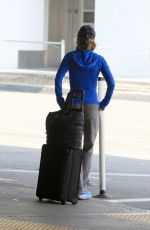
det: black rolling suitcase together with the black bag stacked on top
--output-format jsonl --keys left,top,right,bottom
{"left": 36, "top": 90, "right": 84, "bottom": 204}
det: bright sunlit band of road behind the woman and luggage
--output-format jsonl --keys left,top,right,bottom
{"left": 0, "top": 88, "right": 150, "bottom": 159}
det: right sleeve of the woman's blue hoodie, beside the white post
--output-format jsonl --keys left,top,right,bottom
{"left": 99, "top": 58, "right": 115, "bottom": 109}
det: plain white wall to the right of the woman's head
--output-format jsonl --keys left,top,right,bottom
{"left": 95, "top": 0, "right": 150, "bottom": 79}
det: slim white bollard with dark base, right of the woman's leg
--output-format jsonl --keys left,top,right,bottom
{"left": 95, "top": 77, "right": 110, "bottom": 198}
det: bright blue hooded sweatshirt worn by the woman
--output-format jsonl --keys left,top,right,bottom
{"left": 55, "top": 50, "right": 115, "bottom": 109}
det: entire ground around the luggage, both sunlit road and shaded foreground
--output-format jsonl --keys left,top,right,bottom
{"left": 0, "top": 74, "right": 150, "bottom": 230}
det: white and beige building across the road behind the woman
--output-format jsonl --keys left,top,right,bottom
{"left": 0, "top": 0, "right": 150, "bottom": 79}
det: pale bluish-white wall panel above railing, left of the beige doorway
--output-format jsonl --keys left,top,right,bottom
{"left": 17, "top": 0, "right": 44, "bottom": 41}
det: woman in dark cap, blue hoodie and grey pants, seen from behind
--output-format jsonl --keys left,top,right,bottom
{"left": 55, "top": 25, "right": 115, "bottom": 200}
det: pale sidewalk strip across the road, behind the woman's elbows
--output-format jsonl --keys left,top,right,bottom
{"left": 0, "top": 73, "right": 150, "bottom": 101}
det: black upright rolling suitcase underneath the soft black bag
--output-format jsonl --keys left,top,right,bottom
{"left": 36, "top": 144, "right": 82, "bottom": 204}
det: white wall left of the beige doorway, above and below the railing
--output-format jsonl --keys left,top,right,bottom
{"left": 0, "top": 0, "right": 44, "bottom": 68}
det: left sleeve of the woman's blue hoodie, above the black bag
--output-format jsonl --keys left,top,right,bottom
{"left": 55, "top": 54, "right": 69, "bottom": 109}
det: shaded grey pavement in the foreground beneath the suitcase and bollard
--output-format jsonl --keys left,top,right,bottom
{"left": 0, "top": 146, "right": 150, "bottom": 230}
